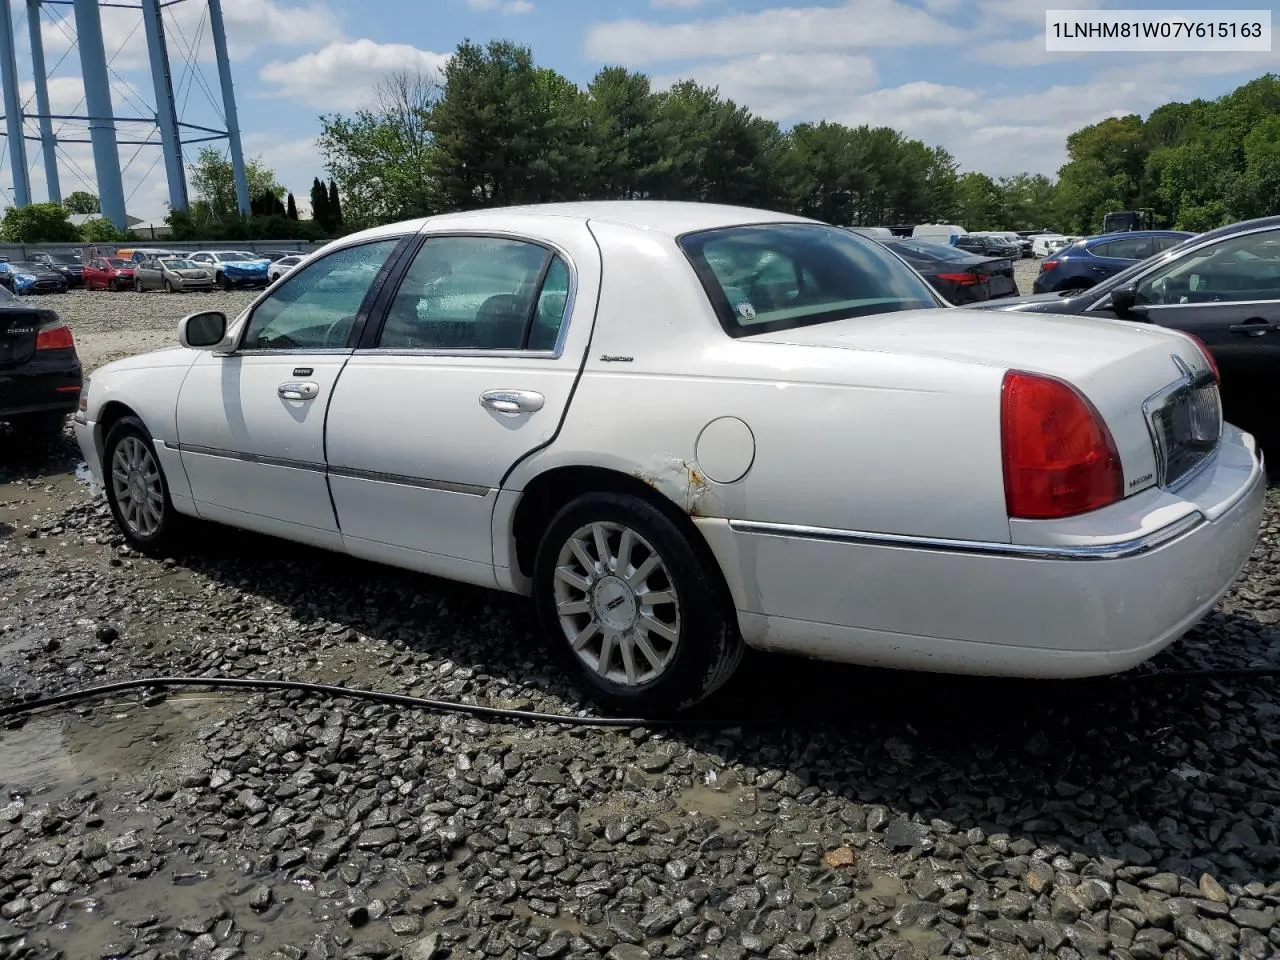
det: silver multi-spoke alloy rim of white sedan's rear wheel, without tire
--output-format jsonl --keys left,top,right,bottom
{"left": 554, "top": 522, "right": 680, "bottom": 687}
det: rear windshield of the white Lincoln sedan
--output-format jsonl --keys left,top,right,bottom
{"left": 680, "top": 223, "right": 942, "bottom": 337}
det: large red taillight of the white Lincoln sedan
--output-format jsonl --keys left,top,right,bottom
{"left": 1000, "top": 370, "right": 1124, "bottom": 520}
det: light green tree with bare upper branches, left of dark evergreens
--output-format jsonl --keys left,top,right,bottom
{"left": 320, "top": 72, "right": 440, "bottom": 228}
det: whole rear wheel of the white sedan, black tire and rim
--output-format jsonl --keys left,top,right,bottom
{"left": 534, "top": 493, "right": 742, "bottom": 717}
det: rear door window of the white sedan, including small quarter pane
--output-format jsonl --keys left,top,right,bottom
{"left": 378, "top": 237, "right": 568, "bottom": 351}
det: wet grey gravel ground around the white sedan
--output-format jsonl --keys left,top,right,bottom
{"left": 0, "top": 271, "right": 1280, "bottom": 960}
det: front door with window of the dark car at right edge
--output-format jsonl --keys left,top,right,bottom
{"left": 1134, "top": 228, "right": 1280, "bottom": 456}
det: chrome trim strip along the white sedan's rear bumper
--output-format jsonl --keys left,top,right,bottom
{"left": 728, "top": 511, "right": 1208, "bottom": 561}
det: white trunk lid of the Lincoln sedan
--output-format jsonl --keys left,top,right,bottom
{"left": 745, "top": 307, "right": 1217, "bottom": 495}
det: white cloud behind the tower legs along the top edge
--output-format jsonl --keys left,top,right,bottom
{"left": 36, "top": 0, "right": 342, "bottom": 72}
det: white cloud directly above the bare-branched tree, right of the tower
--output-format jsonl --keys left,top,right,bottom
{"left": 260, "top": 38, "right": 449, "bottom": 111}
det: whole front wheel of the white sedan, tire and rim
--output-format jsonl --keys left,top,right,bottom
{"left": 102, "top": 416, "right": 183, "bottom": 556}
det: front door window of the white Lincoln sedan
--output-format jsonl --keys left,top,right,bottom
{"left": 241, "top": 237, "right": 401, "bottom": 349}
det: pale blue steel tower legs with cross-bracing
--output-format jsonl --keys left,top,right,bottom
{"left": 0, "top": 0, "right": 250, "bottom": 230}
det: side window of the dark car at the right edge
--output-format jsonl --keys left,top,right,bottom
{"left": 1134, "top": 230, "right": 1280, "bottom": 306}
